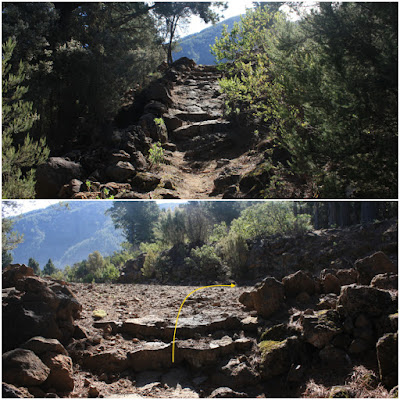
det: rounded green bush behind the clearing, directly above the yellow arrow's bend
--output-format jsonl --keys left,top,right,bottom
{"left": 185, "top": 244, "right": 224, "bottom": 280}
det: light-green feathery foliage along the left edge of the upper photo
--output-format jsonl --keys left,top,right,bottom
{"left": 2, "top": 39, "right": 49, "bottom": 199}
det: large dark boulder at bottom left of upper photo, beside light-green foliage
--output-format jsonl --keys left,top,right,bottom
{"left": 35, "top": 157, "right": 82, "bottom": 199}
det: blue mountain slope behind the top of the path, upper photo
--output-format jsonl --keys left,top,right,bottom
{"left": 173, "top": 15, "right": 240, "bottom": 65}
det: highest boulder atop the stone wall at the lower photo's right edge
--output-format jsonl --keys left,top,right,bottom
{"left": 355, "top": 251, "right": 397, "bottom": 285}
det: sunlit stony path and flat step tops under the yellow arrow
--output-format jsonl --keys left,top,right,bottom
{"left": 67, "top": 283, "right": 255, "bottom": 398}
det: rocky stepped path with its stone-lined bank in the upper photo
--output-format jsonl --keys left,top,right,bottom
{"left": 36, "top": 58, "right": 265, "bottom": 199}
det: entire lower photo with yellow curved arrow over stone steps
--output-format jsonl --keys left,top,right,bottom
{"left": 2, "top": 200, "right": 398, "bottom": 398}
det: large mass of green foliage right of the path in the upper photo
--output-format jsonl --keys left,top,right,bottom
{"left": 213, "top": 2, "right": 397, "bottom": 198}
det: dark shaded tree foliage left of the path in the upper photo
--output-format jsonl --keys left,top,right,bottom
{"left": 2, "top": 2, "right": 163, "bottom": 149}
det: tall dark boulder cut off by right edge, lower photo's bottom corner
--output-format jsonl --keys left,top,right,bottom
{"left": 376, "top": 332, "right": 398, "bottom": 389}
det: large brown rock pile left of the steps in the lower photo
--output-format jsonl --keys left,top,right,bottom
{"left": 2, "top": 264, "right": 82, "bottom": 397}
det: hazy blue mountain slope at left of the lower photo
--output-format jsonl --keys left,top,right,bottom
{"left": 13, "top": 201, "right": 124, "bottom": 268}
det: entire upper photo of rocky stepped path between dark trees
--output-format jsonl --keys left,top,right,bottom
{"left": 2, "top": 1, "right": 398, "bottom": 199}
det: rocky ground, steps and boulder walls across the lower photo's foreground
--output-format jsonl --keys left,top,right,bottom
{"left": 3, "top": 221, "right": 398, "bottom": 398}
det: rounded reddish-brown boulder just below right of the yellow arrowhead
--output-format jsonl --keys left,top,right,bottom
{"left": 251, "top": 277, "right": 285, "bottom": 318}
